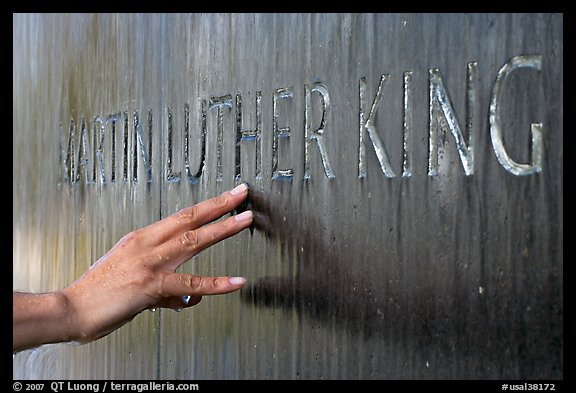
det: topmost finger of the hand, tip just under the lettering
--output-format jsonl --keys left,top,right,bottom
{"left": 146, "top": 183, "right": 248, "bottom": 243}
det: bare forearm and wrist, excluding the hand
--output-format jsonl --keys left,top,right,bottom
{"left": 12, "top": 292, "right": 76, "bottom": 352}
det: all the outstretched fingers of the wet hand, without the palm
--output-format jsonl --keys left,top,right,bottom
{"left": 138, "top": 184, "right": 253, "bottom": 309}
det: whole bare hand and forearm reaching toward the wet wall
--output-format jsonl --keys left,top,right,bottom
{"left": 12, "top": 184, "right": 253, "bottom": 352}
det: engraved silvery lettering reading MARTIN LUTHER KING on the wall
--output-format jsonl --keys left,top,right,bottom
{"left": 58, "top": 55, "right": 543, "bottom": 186}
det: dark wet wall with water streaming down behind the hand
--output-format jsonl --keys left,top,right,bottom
{"left": 13, "top": 14, "right": 563, "bottom": 380}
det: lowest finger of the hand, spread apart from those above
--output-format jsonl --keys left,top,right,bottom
{"left": 161, "top": 273, "right": 246, "bottom": 298}
